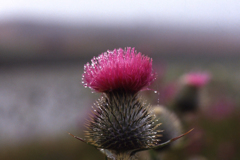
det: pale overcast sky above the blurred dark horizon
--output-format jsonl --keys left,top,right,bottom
{"left": 0, "top": 0, "right": 240, "bottom": 28}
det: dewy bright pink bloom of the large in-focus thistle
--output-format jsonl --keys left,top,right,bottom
{"left": 82, "top": 47, "right": 155, "bottom": 93}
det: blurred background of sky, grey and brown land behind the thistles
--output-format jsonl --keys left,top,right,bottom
{"left": 0, "top": 0, "right": 240, "bottom": 160}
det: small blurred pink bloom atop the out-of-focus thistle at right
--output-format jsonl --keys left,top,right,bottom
{"left": 181, "top": 72, "right": 211, "bottom": 88}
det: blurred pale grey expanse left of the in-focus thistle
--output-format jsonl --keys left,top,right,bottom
{"left": 0, "top": 64, "right": 91, "bottom": 146}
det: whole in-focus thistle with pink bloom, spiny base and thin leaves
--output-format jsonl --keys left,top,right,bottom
{"left": 72, "top": 48, "right": 192, "bottom": 159}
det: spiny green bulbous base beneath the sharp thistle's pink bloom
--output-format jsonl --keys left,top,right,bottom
{"left": 86, "top": 92, "right": 161, "bottom": 153}
